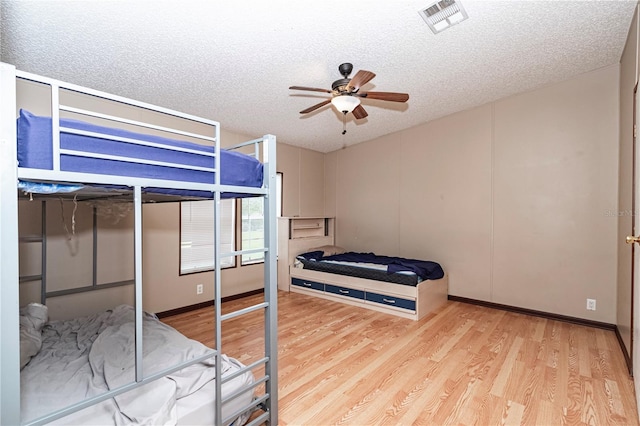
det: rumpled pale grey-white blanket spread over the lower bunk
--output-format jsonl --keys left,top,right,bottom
{"left": 21, "top": 305, "right": 235, "bottom": 425}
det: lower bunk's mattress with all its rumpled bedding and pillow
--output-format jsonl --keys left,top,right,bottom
{"left": 20, "top": 304, "right": 254, "bottom": 425}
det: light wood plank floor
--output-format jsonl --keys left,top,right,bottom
{"left": 164, "top": 292, "right": 638, "bottom": 425}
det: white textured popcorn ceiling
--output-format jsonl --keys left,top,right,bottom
{"left": 0, "top": 0, "right": 636, "bottom": 152}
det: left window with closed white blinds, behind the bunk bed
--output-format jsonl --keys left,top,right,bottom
{"left": 180, "top": 199, "right": 235, "bottom": 275}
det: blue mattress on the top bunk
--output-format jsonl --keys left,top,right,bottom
{"left": 18, "top": 110, "right": 263, "bottom": 195}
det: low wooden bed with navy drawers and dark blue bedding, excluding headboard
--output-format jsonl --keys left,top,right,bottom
{"left": 290, "top": 246, "right": 448, "bottom": 320}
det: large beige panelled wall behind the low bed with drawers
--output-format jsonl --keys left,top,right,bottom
{"left": 325, "top": 66, "right": 619, "bottom": 324}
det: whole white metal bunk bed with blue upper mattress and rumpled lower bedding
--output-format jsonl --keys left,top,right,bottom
{"left": 0, "top": 63, "right": 277, "bottom": 425}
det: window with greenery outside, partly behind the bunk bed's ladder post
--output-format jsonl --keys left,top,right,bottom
{"left": 241, "top": 173, "right": 282, "bottom": 265}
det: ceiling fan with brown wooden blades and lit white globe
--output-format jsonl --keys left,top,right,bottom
{"left": 289, "top": 62, "right": 409, "bottom": 135}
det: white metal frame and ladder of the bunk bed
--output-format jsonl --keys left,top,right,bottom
{"left": 0, "top": 63, "right": 278, "bottom": 425}
